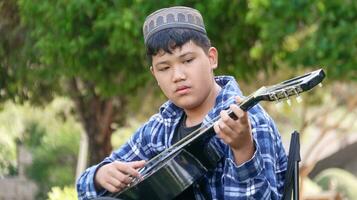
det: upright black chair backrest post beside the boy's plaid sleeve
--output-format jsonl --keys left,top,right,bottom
{"left": 282, "top": 131, "right": 301, "bottom": 200}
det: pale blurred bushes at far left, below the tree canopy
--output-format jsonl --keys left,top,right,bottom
{"left": 0, "top": 98, "right": 81, "bottom": 198}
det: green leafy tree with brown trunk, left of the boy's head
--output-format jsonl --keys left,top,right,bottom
{"left": 14, "top": 0, "right": 154, "bottom": 164}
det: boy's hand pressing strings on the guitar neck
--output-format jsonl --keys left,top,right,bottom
{"left": 214, "top": 97, "right": 255, "bottom": 165}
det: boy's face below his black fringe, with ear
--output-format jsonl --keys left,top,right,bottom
{"left": 150, "top": 41, "right": 217, "bottom": 109}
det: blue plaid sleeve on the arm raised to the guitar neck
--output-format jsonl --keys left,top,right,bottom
{"left": 209, "top": 105, "right": 287, "bottom": 199}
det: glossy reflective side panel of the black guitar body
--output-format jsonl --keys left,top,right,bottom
{"left": 114, "top": 149, "right": 203, "bottom": 200}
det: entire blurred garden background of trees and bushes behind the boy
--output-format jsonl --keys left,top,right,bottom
{"left": 0, "top": 0, "right": 357, "bottom": 200}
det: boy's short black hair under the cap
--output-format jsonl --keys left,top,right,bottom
{"left": 145, "top": 28, "right": 211, "bottom": 63}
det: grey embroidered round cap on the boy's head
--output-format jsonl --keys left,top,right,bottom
{"left": 143, "top": 6, "right": 206, "bottom": 44}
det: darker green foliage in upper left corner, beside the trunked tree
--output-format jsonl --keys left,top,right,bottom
{"left": 0, "top": 0, "right": 55, "bottom": 104}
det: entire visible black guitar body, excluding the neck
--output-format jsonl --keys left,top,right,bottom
{"left": 107, "top": 129, "right": 221, "bottom": 200}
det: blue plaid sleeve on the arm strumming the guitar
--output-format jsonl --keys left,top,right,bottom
{"left": 76, "top": 118, "right": 156, "bottom": 200}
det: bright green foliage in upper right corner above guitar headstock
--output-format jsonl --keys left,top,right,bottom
{"left": 246, "top": 0, "right": 357, "bottom": 80}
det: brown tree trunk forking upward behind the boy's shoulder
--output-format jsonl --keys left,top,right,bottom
{"left": 71, "top": 79, "right": 125, "bottom": 166}
